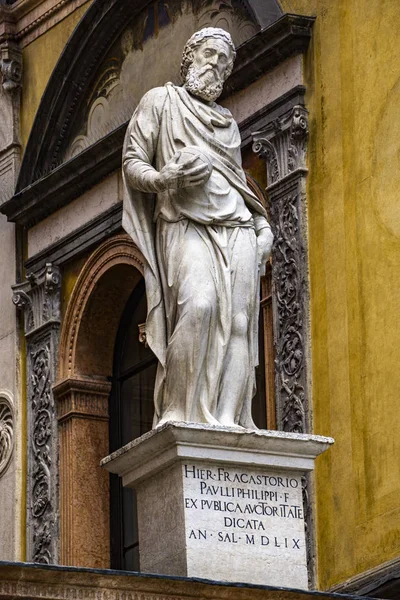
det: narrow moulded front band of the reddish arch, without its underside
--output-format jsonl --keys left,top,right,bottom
{"left": 59, "top": 234, "right": 144, "bottom": 381}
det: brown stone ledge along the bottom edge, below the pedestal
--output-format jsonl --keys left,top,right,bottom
{"left": 0, "top": 562, "right": 370, "bottom": 600}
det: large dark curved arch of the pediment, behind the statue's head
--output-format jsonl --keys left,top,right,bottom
{"left": 16, "top": 0, "right": 283, "bottom": 194}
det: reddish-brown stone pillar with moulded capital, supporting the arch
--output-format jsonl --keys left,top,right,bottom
{"left": 54, "top": 377, "right": 111, "bottom": 569}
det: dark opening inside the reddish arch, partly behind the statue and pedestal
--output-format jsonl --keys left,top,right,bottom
{"left": 109, "top": 279, "right": 157, "bottom": 571}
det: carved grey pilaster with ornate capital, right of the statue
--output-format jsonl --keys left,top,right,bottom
{"left": 253, "top": 105, "right": 310, "bottom": 433}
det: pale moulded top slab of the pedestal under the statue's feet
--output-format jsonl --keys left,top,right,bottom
{"left": 101, "top": 421, "right": 334, "bottom": 486}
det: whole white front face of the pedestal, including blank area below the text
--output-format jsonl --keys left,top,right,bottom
{"left": 182, "top": 462, "right": 307, "bottom": 587}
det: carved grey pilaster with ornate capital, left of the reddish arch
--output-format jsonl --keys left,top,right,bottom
{"left": 13, "top": 264, "right": 61, "bottom": 564}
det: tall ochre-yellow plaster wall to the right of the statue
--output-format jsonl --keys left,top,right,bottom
{"left": 282, "top": 0, "right": 400, "bottom": 589}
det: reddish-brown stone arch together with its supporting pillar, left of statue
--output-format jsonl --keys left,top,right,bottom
{"left": 53, "top": 234, "right": 144, "bottom": 568}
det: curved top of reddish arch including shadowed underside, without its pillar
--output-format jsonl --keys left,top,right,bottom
{"left": 59, "top": 235, "right": 144, "bottom": 380}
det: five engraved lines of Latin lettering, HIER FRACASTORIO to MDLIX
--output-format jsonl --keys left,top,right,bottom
{"left": 183, "top": 463, "right": 305, "bottom": 559}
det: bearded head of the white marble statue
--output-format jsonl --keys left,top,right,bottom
{"left": 181, "top": 27, "right": 236, "bottom": 101}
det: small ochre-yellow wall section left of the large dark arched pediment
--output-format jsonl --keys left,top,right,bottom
{"left": 21, "top": 2, "right": 89, "bottom": 149}
